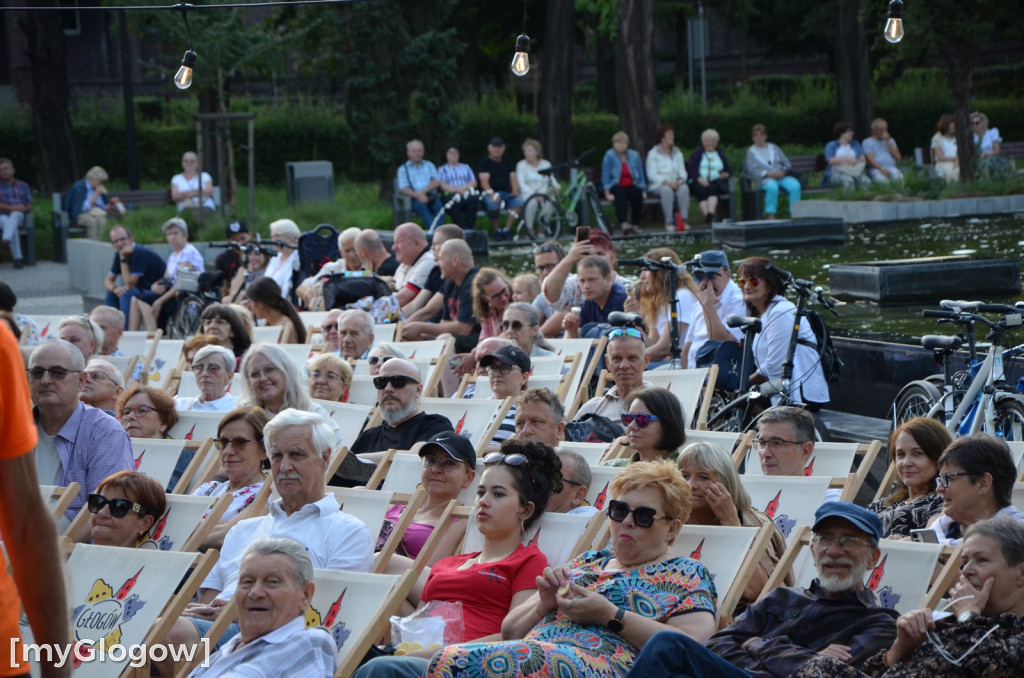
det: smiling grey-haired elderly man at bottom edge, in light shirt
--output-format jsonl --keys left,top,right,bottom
{"left": 188, "top": 537, "right": 338, "bottom": 678}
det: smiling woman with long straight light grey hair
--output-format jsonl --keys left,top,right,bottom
{"left": 241, "top": 344, "right": 341, "bottom": 446}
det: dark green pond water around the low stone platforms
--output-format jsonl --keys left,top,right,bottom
{"left": 488, "top": 214, "right": 1024, "bottom": 344}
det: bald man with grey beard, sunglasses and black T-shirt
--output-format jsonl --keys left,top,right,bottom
{"left": 331, "top": 357, "right": 455, "bottom": 486}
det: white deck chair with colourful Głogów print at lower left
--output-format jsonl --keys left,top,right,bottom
{"left": 59, "top": 544, "right": 218, "bottom": 678}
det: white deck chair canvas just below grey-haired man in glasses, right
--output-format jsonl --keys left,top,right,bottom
{"left": 742, "top": 475, "right": 830, "bottom": 544}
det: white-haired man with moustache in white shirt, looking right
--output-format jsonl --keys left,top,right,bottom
{"left": 155, "top": 408, "right": 374, "bottom": 676}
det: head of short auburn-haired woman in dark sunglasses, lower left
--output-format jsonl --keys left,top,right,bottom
{"left": 86, "top": 471, "right": 167, "bottom": 549}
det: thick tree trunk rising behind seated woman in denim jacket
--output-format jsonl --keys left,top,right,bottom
{"left": 615, "top": 0, "right": 659, "bottom": 151}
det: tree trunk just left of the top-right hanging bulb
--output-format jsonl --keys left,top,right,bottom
{"left": 834, "top": 0, "right": 874, "bottom": 137}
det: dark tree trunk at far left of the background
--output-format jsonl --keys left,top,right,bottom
{"left": 19, "top": 5, "right": 78, "bottom": 192}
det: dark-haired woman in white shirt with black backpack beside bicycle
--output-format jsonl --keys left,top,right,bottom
{"left": 736, "top": 257, "right": 828, "bottom": 412}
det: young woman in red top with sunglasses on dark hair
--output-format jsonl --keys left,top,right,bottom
{"left": 353, "top": 439, "right": 562, "bottom": 678}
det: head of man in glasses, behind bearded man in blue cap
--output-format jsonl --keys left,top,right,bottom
{"left": 751, "top": 405, "right": 843, "bottom": 502}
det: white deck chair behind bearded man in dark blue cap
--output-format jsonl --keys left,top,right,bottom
{"left": 761, "top": 526, "right": 963, "bottom": 615}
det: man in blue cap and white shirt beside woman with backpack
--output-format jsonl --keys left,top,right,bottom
{"left": 680, "top": 250, "right": 746, "bottom": 370}
